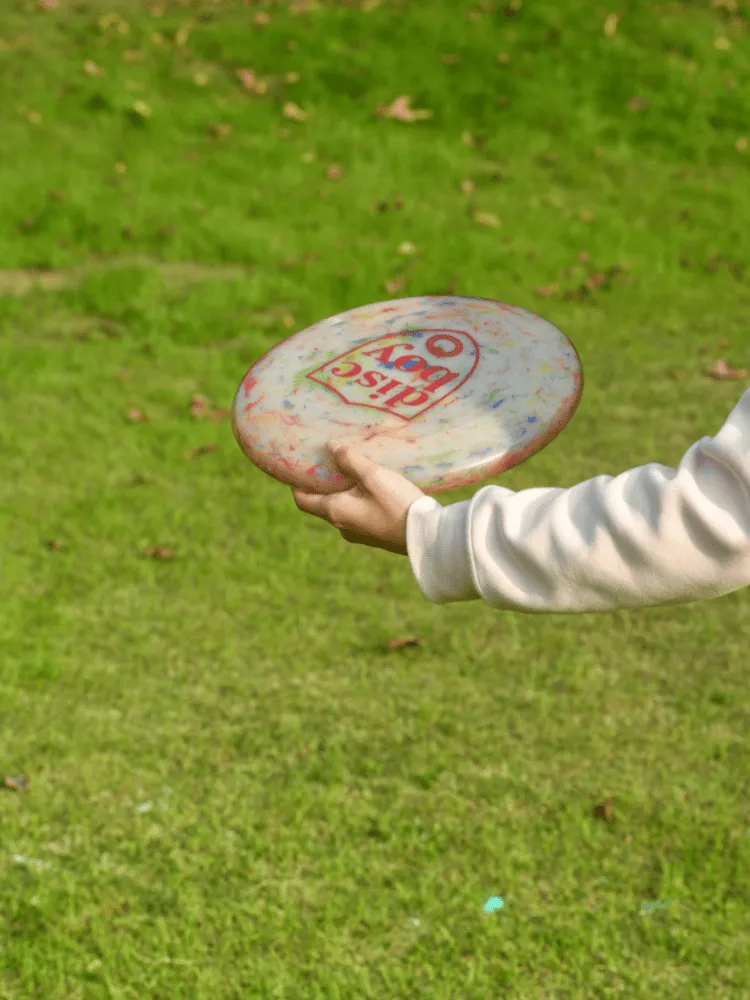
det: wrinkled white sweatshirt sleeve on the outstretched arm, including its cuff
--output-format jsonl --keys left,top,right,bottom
{"left": 407, "top": 390, "right": 750, "bottom": 614}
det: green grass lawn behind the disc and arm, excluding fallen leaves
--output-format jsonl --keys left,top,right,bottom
{"left": 0, "top": 0, "right": 750, "bottom": 1000}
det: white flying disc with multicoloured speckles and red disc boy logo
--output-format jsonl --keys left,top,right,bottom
{"left": 232, "top": 295, "right": 583, "bottom": 494}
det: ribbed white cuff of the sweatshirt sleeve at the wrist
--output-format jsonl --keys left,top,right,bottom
{"left": 406, "top": 496, "right": 481, "bottom": 604}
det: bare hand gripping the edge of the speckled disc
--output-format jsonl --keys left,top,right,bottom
{"left": 292, "top": 441, "right": 424, "bottom": 556}
